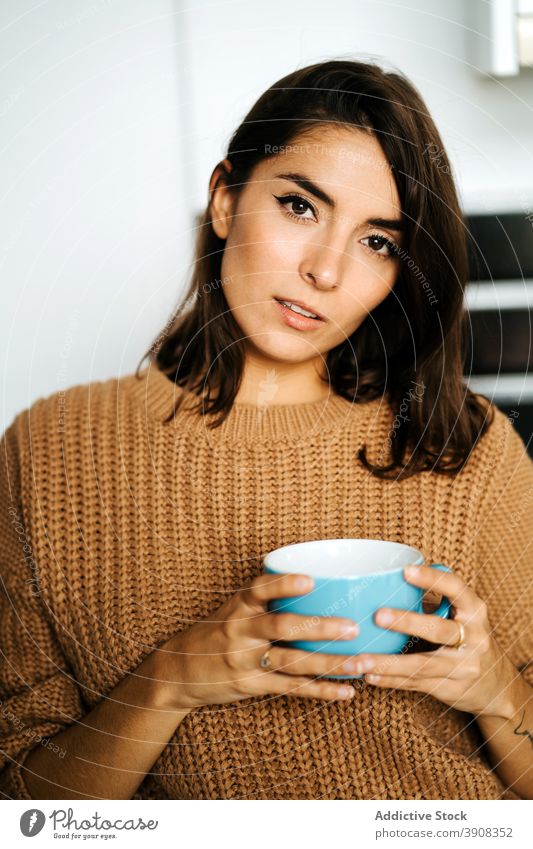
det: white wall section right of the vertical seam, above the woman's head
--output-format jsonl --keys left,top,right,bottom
{"left": 182, "top": 0, "right": 533, "bottom": 211}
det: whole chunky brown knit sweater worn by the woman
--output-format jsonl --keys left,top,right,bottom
{"left": 0, "top": 367, "right": 533, "bottom": 799}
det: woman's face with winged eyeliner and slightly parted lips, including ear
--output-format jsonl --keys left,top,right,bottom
{"left": 211, "top": 127, "right": 401, "bottom": 373}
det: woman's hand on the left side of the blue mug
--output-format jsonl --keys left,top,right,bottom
{"left": 156, "top": 574, "right": 359, "bottom": 710}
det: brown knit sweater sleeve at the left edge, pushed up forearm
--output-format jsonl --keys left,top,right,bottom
{"left": 0, "top": 411, "right": 83, "bottom": 799}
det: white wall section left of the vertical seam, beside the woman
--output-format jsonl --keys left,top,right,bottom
{"left": 0, "top": 0, "right": 191, "bottom": 426}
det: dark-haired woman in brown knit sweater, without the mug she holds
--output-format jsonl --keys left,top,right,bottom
{"left": 0, "top": 61, "right": 533, "bottom": 799}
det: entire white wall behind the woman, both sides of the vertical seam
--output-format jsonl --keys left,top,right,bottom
{"left": 0, "top": 0, "right": 533, "bottom": 426}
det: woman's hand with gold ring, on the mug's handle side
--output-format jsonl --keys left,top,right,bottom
{"left": 350, "top": 566, "right": 518, "bottom": 716}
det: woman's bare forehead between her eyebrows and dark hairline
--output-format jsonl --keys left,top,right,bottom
{"left": 254, "top": 125, "right": 400, "bottom": 213}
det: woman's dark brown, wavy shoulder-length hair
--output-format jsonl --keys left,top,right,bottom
{"left": 136, "top": 60, "right": 493, "bottom": 479}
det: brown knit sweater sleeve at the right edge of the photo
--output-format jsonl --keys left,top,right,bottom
{"left": 475, "top": 408, "right": 533, "bottom": 685}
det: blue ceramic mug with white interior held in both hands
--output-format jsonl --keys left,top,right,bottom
{"left": 263, "top": 539, "right": 452, "bottom": 678}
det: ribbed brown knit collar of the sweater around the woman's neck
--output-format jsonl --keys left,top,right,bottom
{"left": 129, "top": 365, "right": 376, "bottom": 441}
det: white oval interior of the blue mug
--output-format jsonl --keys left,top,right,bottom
{"left": 263, "top": 538, "right": 424, "bottom": 578}
